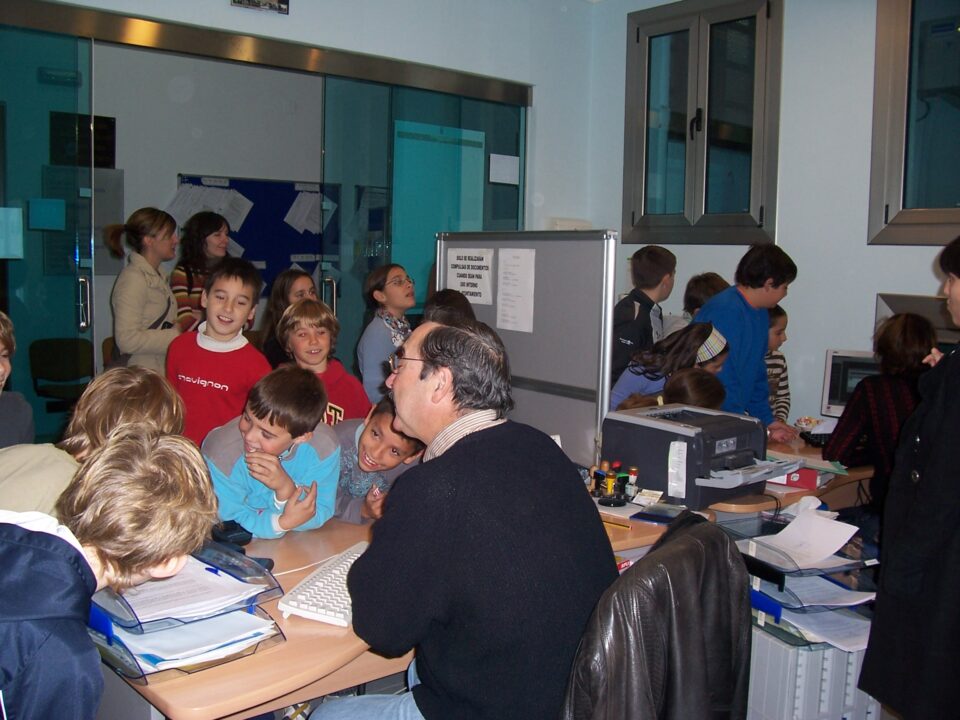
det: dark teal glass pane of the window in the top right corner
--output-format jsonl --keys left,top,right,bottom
{"left": 903, "top": 0, "right": 960, "bottom": 209}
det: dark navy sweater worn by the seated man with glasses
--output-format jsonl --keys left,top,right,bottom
{"left": 348, "top": 422, "right": 617, "bottom": 720}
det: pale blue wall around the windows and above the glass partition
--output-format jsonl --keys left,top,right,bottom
{"left": 62, "top": 0, "right": 952, "bottom": 416}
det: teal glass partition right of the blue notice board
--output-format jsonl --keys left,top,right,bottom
{"left": 323, "top": 77, "right": 525, "bottom": 367}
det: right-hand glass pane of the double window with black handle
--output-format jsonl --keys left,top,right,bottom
{"left": 705, "top": 17, "right": 756, "bottom": 214}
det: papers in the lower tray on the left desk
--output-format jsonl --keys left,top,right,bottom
{"left": 115, "top": 610, "right": 278, "bottom": 672}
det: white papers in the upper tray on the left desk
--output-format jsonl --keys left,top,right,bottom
{"left": 123, "top": 556, "right": 263, "bottom": 623}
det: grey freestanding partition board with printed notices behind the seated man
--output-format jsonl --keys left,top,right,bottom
{"left": 437, "top": 230, "right": 617, "bottom": 466}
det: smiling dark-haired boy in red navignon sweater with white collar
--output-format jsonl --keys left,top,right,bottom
{"left": 167, "top": 257, "right": 270, "bottom": 446}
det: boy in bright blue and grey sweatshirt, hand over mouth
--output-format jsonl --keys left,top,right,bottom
{"left": 203, "top": 365, "right": 340, "bottom": 538}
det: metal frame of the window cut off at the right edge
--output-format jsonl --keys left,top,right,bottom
{"left": 867, "top": 0, "right": 960, "bottom": 245}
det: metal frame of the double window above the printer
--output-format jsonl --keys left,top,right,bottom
{"left": 621, "top": 0, "right": 783, "bottom": 245}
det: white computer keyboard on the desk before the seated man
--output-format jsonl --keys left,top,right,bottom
{"left": 278, "top": 541, "right": 370, "bottom": 627}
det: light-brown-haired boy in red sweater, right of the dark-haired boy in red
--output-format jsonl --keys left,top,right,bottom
{"left": 277, "top": 298, "right": 370, "bottom": 425}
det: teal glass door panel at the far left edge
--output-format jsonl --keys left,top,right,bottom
{"left": 0, "top": 26, "right": 93, "bottom": 442}
